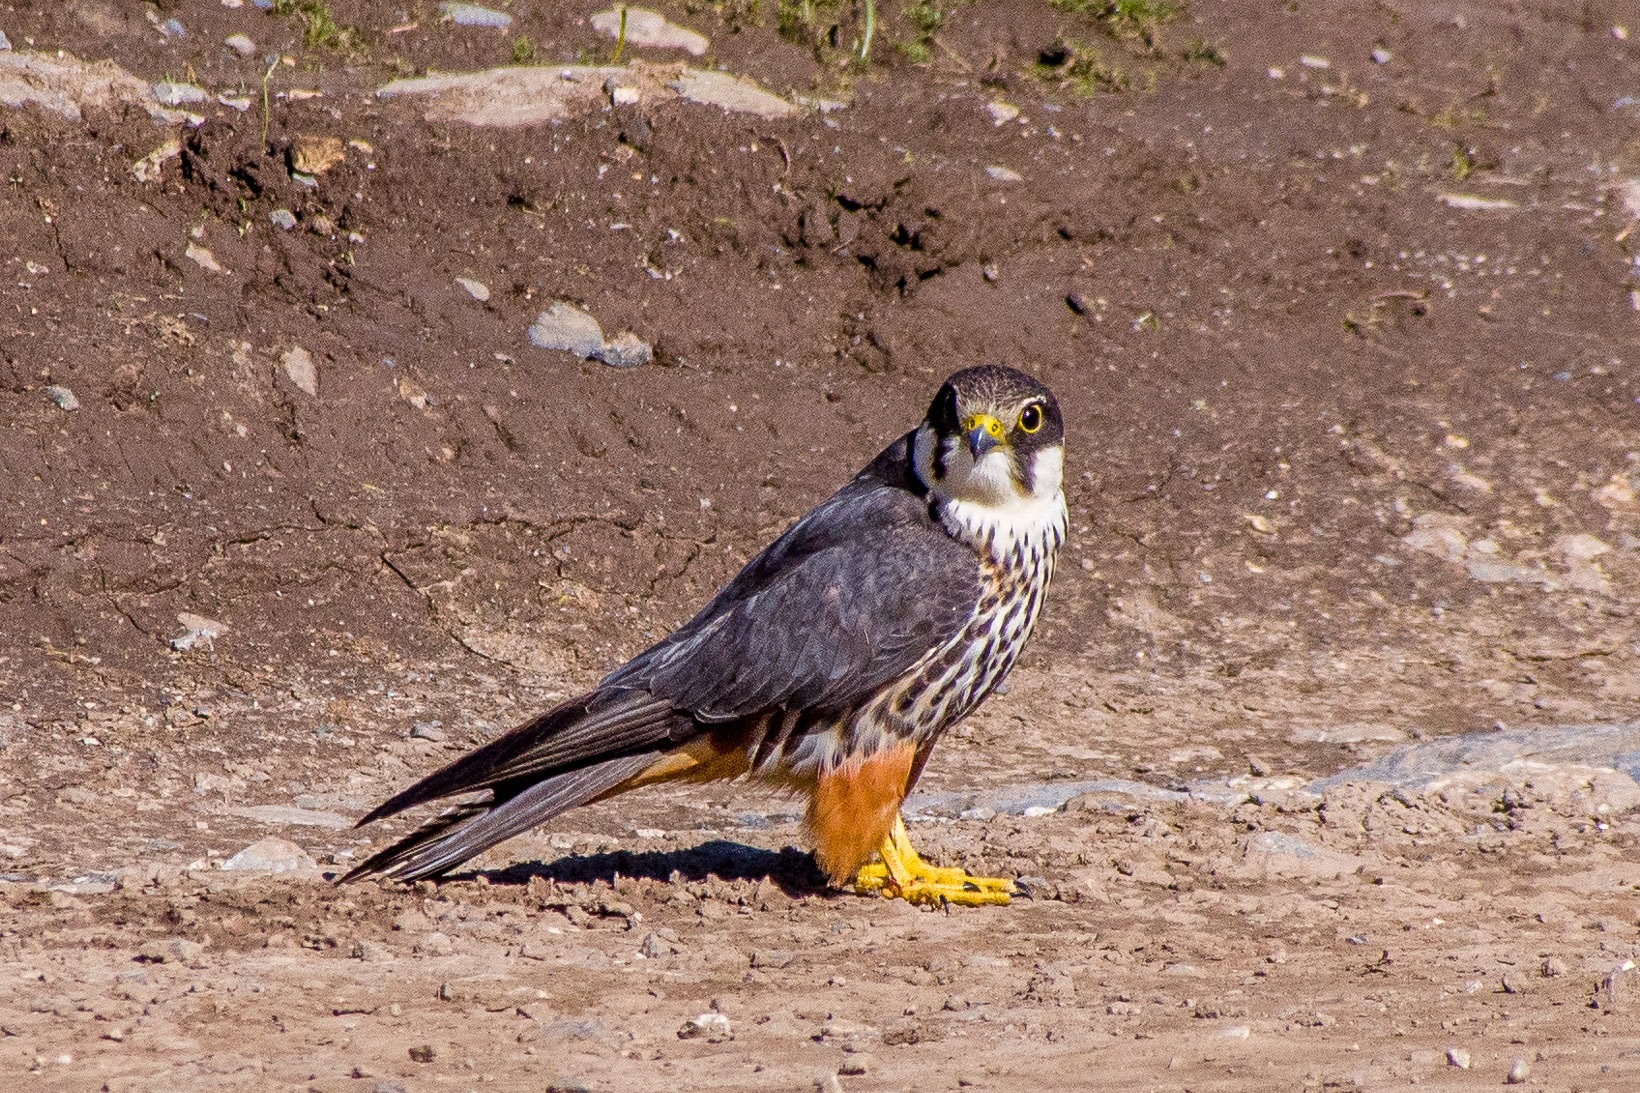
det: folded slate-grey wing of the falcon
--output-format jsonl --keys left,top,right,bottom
{"left": 602, "top": 479, "right": 982, "bottom": 722}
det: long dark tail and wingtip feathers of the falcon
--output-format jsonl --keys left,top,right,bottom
{"left": 341, "top": 691, "right": 700, "bottom": 883}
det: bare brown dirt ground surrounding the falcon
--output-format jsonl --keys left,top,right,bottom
{"left": 0, "top": 0, "right": 1640, "bottom": 1093}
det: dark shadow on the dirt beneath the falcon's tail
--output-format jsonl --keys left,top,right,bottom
{"left": 451, "top": 839, "right": 830, "bottom": 899}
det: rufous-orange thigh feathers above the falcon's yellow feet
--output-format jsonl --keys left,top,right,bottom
{"left": 804, "top": 742, "right": 917, "bottom": 886}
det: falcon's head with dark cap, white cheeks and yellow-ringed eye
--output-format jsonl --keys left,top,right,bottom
{"left": 912, "top": 364, "right": 1064, "bottom": 509}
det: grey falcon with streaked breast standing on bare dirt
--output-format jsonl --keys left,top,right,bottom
{"left": 343, "top": 366, "right": 1066, "bottom": 904}
